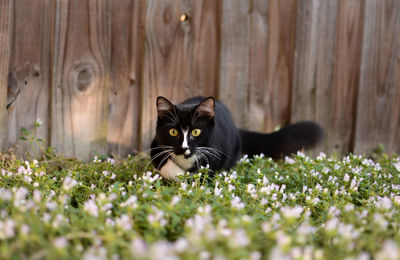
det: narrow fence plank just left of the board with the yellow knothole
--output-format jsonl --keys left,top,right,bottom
{"left": 107, "top": 0, "right": 145, "bottom": 156}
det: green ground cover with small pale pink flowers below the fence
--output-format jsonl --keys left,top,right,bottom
{"left": 0, "top": 153, "right": 400, "bottom": 259}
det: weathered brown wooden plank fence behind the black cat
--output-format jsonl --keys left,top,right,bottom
{"left": 0, "top": 0, "right": 400, "bottom": 159}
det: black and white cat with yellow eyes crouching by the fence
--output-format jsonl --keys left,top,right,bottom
{"left": 151, "top": 97, "right": 323, "bottom": 180}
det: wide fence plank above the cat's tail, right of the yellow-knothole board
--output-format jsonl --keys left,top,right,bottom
{"left": 219, "top": 0, "right": 297, "bottom": 132}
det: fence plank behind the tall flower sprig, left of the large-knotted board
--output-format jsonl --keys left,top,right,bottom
{"left": 5, "top": 0, "right": 53, "bottom": 155}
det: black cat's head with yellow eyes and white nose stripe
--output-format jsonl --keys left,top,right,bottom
{"left": 156, "top": 97, "right": 215, "bottom": 158}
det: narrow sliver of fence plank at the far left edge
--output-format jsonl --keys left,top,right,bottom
{"left": 0, "top": 0, "right": 11, "bottom": 151}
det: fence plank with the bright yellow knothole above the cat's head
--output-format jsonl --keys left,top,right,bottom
{"left": 141, "top": 0, "right": 219, "bottom": 149}
